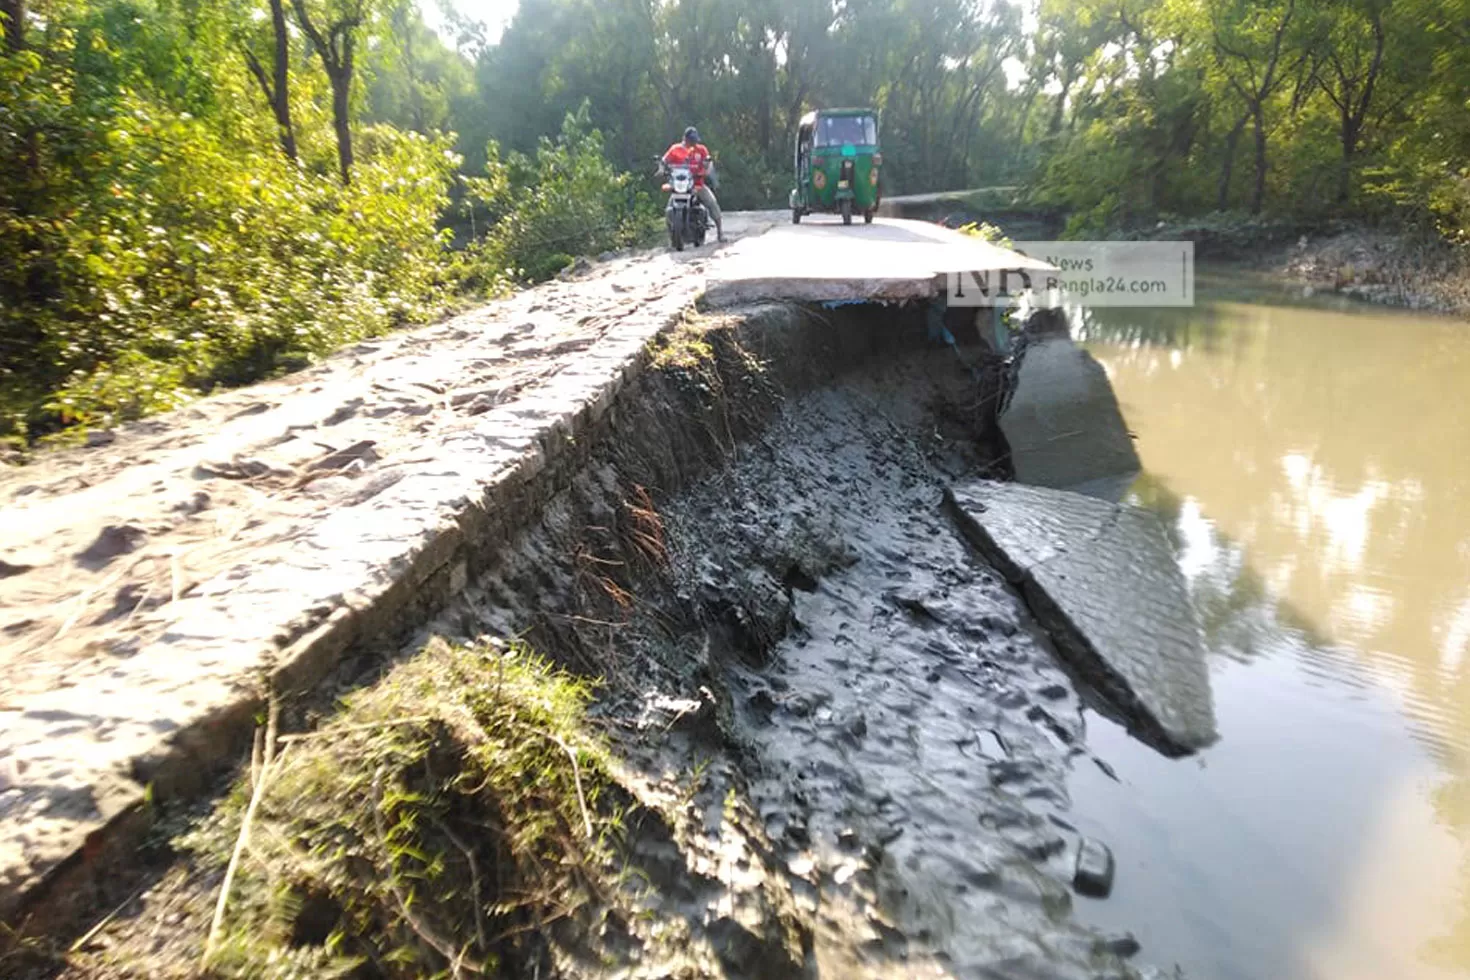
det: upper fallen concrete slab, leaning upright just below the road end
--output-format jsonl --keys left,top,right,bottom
{"left": 1000, "top": 335, "right": 1141, "bottom": 501}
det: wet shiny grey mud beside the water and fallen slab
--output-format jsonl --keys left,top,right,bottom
{"left": 664, "top": 351, "right": 1170, "bottom": 977}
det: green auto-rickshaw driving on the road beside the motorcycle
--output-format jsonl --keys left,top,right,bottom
{"left": 791, "top": 109, "right": 883, "bottom": 225}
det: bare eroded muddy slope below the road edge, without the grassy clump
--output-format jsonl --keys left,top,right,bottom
{"left": 31, "top": 309, "right": 1152, "bottom": 980}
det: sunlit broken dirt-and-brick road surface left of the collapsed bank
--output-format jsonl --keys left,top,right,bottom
{"left": 0, "top": 220, "right": 793, "bottom": 914}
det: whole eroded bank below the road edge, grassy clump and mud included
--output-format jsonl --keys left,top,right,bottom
{"left": 12, "top": 307, "right": 1155, "bottom": 979}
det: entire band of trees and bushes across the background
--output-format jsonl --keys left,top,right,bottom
{"left": 0, "top": 0, "right": 1470, "bottom": 438}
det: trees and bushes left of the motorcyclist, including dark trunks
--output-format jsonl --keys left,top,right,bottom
{"left": 0, "top": 0, "right": 656, "bottom": 438}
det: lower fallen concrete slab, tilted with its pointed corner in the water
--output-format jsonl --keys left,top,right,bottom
{"left": 947, "top": 480, "right": 1216, "bottom": 755}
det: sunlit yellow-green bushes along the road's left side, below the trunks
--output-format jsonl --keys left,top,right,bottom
{"left": 0, "top": 17, "right": 459, "bottom": 438}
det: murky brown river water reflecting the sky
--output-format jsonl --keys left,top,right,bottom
{"left": 1070, "top": 276, "right": 1470, "bottom": 980}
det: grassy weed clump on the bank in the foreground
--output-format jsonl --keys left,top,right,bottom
{"left": 182, "top": 641, "right": 620, "bottom": 979}
